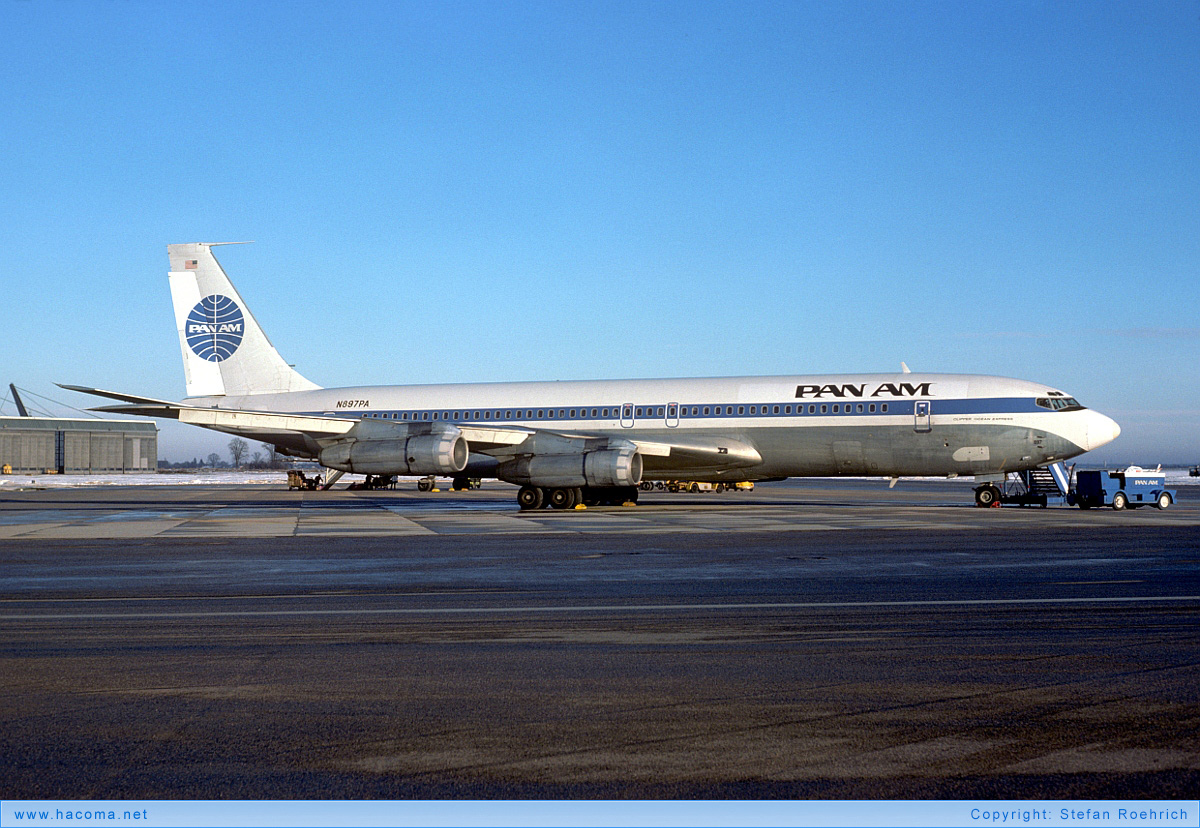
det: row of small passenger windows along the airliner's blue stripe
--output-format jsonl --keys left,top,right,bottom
{"left": 367, "top": 402, "right": 888, "bottom": 422}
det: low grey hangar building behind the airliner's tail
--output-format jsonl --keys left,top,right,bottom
{"left": 0, "top": 416, "right": 158, "bottom": 474}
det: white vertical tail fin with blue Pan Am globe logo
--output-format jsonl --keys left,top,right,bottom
{"left": 167, "top": 244, "right": 320, "bottom": 397}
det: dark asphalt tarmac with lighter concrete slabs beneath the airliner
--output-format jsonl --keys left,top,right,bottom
{"left": 0, "top": 481, "right": 1200, "bottom": 799}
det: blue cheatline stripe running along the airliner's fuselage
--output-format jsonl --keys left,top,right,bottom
{"left": 295, "top": 397, "right": 1052, "bottom": 425}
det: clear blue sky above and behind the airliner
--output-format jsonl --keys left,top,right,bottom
{"left": 0, "top": 0, "right": 1200, "bottom": 463}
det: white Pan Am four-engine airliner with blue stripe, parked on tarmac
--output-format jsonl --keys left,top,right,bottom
{"left": 64, "top": 244, "right": 1121, "bottom": 509}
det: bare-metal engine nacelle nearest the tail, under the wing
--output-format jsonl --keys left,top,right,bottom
{"left": 318, "top": 428, "right": 470, "bottom": 475}
